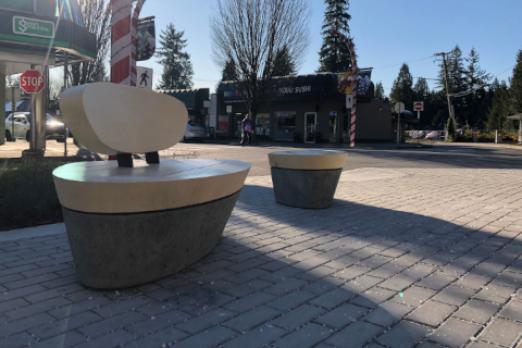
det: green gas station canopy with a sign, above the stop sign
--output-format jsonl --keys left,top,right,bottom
{"left": 0, "top": 0, "right": 97, "bottom": 75}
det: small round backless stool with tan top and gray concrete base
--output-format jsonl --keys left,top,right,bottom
{"left": 268, "top": 150, "right": 347, "bottom": 209}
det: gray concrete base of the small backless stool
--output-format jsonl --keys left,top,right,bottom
{"left": 272, "top": 167, "right": 342, "bottom": 209}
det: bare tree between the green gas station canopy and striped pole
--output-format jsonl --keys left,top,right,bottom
{"left": 70, "top": 0, "right": 111, "bottom": 86}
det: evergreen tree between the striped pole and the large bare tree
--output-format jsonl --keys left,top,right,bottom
{"left": 158, "top": 24, "right": 194, "bottom": 89}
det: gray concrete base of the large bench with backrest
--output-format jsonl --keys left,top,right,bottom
{"left": 63, "top": 193, "right": 239, "bottom": 289}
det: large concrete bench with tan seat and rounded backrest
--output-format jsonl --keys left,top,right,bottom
{"left": 53, "top": 84, "right": 250, "bottom": 289}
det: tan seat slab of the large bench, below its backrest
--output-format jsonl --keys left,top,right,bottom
{"left": 53, "top": 160, "right": 250, "bottom": 213}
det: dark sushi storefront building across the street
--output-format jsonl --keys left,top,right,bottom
{"left": 216, "top": 69, "right": 393, "bottom": 143}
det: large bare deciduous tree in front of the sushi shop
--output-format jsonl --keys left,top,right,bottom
{"left": 212, "top": 0, "right": 309, "bottom": 119}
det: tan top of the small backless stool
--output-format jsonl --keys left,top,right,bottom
{"left": 268, "top": 150, "right": 348, "bottom": 170}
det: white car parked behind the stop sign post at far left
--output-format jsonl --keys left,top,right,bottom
{"left": 5, "top": 112, "right": 65, "bottom": 141}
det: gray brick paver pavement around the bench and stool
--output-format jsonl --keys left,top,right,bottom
{"left": 0, "top": 169, "right": 522, "bottom": 348}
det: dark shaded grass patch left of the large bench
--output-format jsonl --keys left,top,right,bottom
{"left": 0, "top": 158, "right": 73, "bottom": 231}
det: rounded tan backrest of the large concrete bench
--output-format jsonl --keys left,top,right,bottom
{"left": 60, "top": 83, "right": 188, "bottom": 155}
